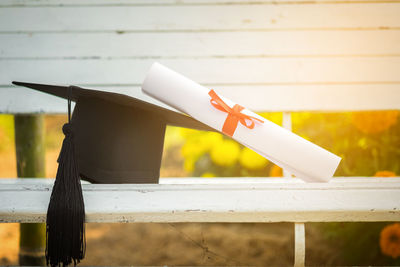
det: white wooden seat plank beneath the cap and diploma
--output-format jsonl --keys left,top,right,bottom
{"left": 0, "top": 177, "right": 400, "bottom": 222}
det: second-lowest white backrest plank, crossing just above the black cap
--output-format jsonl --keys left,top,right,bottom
{"left": 0, "top": 57, "right": 400, "bottom": 86}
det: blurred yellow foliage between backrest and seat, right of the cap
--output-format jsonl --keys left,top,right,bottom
{"left": 181, "top": 111, "right": 400, "bottom": 177}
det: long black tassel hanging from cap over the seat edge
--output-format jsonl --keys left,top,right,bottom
{"left": 46, "top": 90, "right": 86, "bottom": 267}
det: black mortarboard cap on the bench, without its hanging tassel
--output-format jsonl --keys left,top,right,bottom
{"left": 13, "top": 82, "right": 212, "bottom": 184}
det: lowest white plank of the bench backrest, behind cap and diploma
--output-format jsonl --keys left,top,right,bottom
{"left": 0, "top": 84, "right": 400, "bottom": 114}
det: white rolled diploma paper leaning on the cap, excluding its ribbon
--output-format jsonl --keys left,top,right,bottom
{"left": 142, "top": 63, "right": 341, "bottom": 182}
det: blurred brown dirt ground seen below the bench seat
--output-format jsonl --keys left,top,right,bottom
{"left": 0, "top": 223, "right": 336, "bottom": 266}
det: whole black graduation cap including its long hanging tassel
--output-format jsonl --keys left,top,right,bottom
{"left": 13, "top": 82, "right": 212, "bottom": 266}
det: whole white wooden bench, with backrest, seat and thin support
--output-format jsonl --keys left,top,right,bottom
{"left": 0, "top": 0, "right": 400, "bottom": 266}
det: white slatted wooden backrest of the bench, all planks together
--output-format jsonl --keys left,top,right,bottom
{"left": 0, "top": 0, "right": 400, "bottom": 113}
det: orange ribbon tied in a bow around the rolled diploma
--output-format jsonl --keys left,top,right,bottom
{"left": 208, "top": 90, "right": 264, "bottom": 137}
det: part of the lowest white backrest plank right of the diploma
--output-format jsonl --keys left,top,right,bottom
{"left": 215, "top": 84, "right": 400, "bottom": 111}
